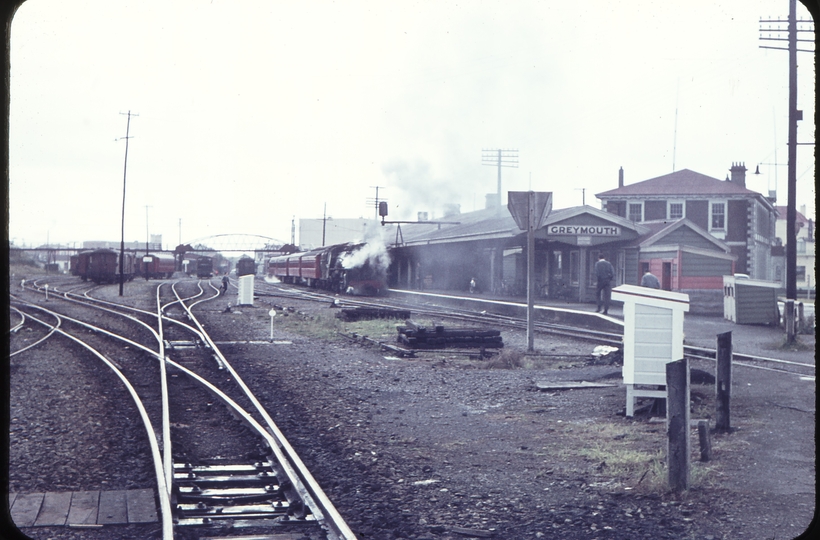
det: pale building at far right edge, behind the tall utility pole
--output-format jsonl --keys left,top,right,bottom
{"left": 772, "top": 205, "right": 817, "bottom": 291}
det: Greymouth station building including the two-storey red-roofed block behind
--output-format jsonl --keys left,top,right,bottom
{"left": 388, "top": 165, "right": 777, "bottom": 315}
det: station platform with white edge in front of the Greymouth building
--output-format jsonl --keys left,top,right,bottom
{"left": 390, "top": 289, "right": 815, "bottom": 363}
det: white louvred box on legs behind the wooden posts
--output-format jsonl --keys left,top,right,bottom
{"left": 612, "top": 285, "right": 689, "bottom": 416}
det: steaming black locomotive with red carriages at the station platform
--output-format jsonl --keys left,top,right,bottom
{"left": 267, "top": 243, "right": 389, "bottom": 296}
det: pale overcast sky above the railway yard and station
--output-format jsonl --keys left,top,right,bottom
{"left": 9, "top": 0, "right": 815, "bottom": 248}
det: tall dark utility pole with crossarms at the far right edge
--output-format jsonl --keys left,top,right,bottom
{"left": 760, "top": 0, "right": 814, "bottom": 343}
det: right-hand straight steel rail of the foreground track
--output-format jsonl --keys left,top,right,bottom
{"left": 178, "top": 281, "right": 356, "bottom": 539}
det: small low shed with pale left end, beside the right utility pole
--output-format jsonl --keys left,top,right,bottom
{"left": 723, "top": 275, "right": 780, "bottom": 325}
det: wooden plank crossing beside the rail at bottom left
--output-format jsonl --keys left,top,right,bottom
{"left": 9, "top": 489, "right": 157, "bottom": 528}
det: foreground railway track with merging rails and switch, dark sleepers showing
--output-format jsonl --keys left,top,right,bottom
{"left": 11, "top": 281, "right": 355, "bottom": 540}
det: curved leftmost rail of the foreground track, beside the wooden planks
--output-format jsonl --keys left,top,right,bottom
{"left": 10, "top": 302, "right": 174, "bottom": 540}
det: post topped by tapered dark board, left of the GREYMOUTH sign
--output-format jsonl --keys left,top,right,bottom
{"left": 507, "top": 191, "right": 552, "bottom": 352}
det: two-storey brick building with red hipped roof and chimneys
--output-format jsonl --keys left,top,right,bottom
{"left": 596, "top": 163, "right": 777, "bottom": 281}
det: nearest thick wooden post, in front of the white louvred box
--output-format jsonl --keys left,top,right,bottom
{"left": 666, "top": 358, "right": 690, "bottom": 492}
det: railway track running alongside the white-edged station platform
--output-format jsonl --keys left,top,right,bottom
{"left": 250, "top": 283, "right": 815, "bottom": 377}
